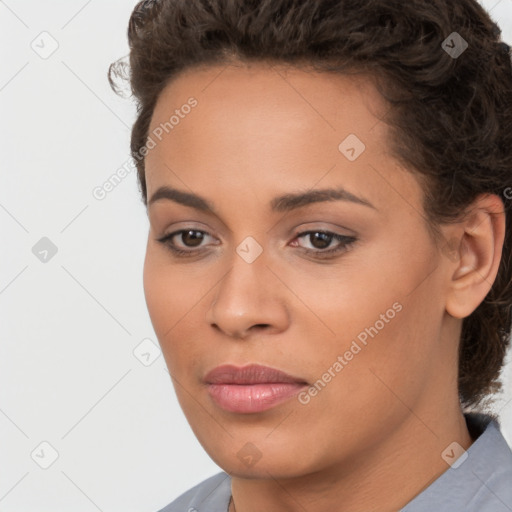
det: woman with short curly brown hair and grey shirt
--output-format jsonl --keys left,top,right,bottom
{"left": 109, "top": 0, "right": 512, "bottom": 512}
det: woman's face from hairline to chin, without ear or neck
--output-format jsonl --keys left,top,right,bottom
{"left": 144, "top": 64, "right": 457, "bottom": 478}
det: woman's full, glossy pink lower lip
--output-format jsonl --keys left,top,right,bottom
{"left": 208, "top": 382, "right": 307, "bottom": 413}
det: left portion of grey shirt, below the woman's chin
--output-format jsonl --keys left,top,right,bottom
{"left": 154, "top": 471, "right": 231, "bottom": 512}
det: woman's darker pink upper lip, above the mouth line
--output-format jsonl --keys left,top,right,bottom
{"left": 204, "top": 364, "right": 307, "bottom": 384}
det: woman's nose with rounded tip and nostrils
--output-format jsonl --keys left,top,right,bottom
{"left": 206, "top": 255, "right": 289, "bottom": 339}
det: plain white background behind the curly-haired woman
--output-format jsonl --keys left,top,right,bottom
{"left": 0, "top": 0, "right": 512, "bottom": 512}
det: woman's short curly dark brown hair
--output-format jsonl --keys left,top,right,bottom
{"left": 108, "top": 0, "right": 512, "bottom": 409}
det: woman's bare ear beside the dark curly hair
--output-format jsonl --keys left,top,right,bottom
{"left": 446, "top": 194, "right": 505, "bottom": 318}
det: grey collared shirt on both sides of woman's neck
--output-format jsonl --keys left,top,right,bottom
{"left": 159, "top": 413, "right": 512, "bottom": 512}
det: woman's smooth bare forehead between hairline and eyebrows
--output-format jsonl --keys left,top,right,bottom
{"left": 146, "top": 64, "right": 420, "bottom": 214}
